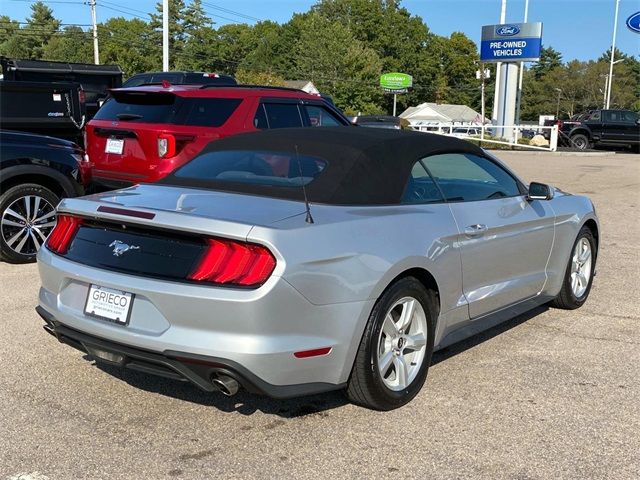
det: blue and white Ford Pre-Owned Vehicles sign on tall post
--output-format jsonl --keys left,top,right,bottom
{"left": 480, "top": 22, "right": 542, "bottom": 62}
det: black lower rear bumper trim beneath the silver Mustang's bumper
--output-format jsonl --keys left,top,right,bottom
{"left": 36, "top": 306, "right": 345, "bottom": 399}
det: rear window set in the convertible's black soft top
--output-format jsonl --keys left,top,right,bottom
{"left": 173, "top": 150, "right": 327, "bottom": 187}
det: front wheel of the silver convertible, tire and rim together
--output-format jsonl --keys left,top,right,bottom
{"left": 551, "top": 227, "right": 597, "bottom": 310}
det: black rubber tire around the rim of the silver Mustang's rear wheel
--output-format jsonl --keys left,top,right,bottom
{"left": 346, "top": 277, "right": 437, "bottom": 410}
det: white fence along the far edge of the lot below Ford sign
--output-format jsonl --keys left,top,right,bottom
{"left": 410, "top": 123, "right": 558, "bottom": 152}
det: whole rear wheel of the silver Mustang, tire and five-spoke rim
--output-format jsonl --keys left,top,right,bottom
{"left": 347, "top": 277, "right": 437, "bottom": 410}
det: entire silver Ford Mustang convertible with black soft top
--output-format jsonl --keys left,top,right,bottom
{"left": 37, "top": 127, "right": 599, "bottom": 410}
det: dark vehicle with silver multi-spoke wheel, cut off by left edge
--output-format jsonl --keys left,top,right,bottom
{"left": 0, "top": 130, "right": 88, "bottom": 263}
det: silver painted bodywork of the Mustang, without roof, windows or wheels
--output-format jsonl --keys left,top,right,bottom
{"left": 38, "top": 176, "right": 597, "bottom": 385}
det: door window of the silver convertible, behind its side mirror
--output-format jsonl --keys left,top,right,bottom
{"left": 423, "top": 153, "right": 521, "bottom": 202}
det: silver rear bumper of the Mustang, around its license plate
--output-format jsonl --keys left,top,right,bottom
{"left": 38, "top": 247, "right": 373, "bottom": 397}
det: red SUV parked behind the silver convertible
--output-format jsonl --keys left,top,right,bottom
{"left": 85, "top": 84, "right": 351, "bottom": 188}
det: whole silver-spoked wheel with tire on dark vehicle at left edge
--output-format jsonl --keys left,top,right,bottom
{"left": 0, "top": 183, "right": 60, "bottom": 263}
